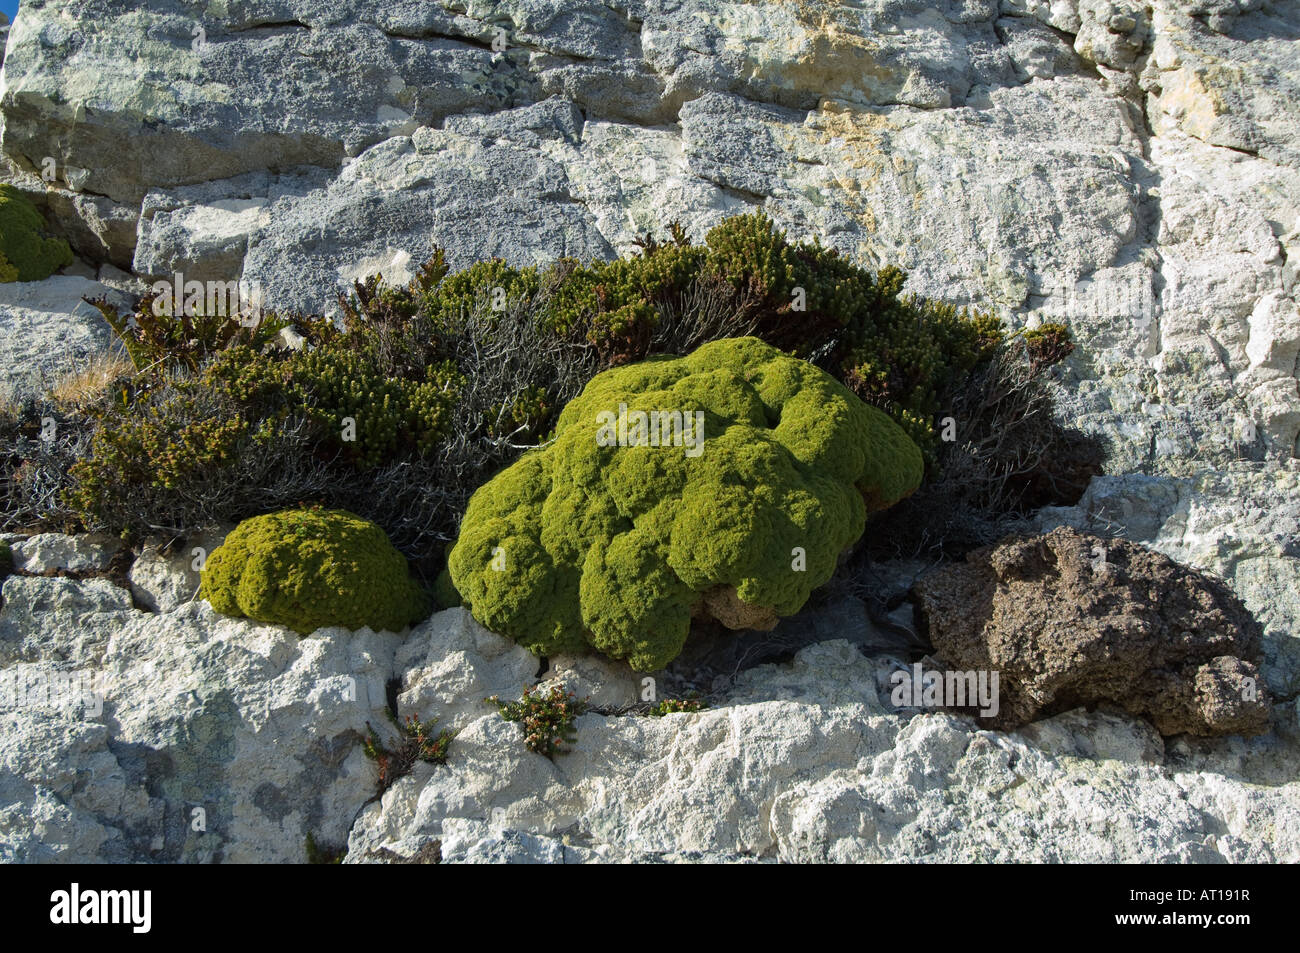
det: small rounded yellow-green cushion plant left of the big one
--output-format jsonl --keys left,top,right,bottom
{"left": 202, "top": 508, "right": 429, "bottom": 636}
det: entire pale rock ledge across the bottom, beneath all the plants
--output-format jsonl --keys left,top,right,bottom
{"left": 0, "top": 579, "right": 1300, "bottom": 862}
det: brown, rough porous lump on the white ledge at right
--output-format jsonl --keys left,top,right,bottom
{"left": 913, "top": 528, "right": 1270, "bottom": 736}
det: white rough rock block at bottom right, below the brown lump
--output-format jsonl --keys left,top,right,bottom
{"left": 348, "top": 642, "right": 1300, "bottom": 862}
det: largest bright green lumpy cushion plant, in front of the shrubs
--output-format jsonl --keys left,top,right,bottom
{"left": 449, "top": 338, "right": 924, "bottom": 671}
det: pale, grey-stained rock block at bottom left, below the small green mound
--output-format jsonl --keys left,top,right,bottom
{"left": 0, "top": 579, "right": 402, "bottom": 862}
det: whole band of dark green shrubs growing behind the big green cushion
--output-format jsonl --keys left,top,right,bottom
{"left": 20, "top": 213, "right": 1067, "bottom": 577}
